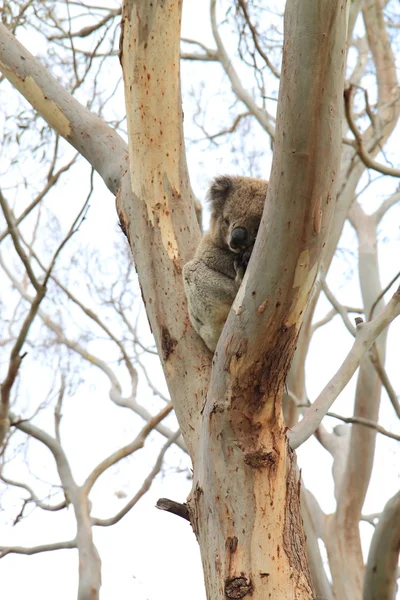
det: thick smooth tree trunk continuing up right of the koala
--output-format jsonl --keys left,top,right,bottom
{"left": 189, "top": 0, "right": 346, "bottom": 600}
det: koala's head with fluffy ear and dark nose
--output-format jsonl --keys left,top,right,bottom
{"left": 208, "top": 176, "right": 268, "bottom": 253}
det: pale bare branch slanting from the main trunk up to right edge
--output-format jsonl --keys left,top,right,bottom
{"left": 287, "top": 288, "right": 400, "bottom": 450}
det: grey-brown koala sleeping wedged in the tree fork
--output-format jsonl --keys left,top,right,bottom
{"left": 183, "top": 176, "right": 268, "bottom": 352}
